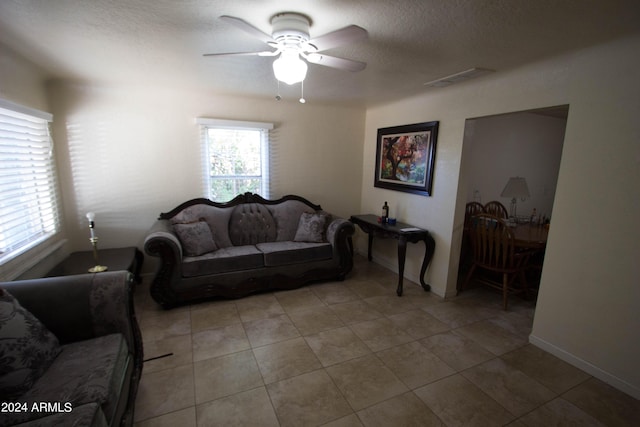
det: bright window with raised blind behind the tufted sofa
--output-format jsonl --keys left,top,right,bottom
{"left": 197, "top": 118, "right": 273, "bottom": 202}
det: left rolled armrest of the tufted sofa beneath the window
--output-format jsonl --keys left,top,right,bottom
{"left": 144, "top": 219, "right": 183, "bottom": 308}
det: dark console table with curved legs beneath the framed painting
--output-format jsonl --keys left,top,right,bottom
{"left": 349, "top": 214, "right": 436, "bottom": 296}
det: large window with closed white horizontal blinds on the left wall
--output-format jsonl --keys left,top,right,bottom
{"left": 0, "top": 100, "right": 60, "bottom": 265}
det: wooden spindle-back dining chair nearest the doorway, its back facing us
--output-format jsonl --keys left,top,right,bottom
{"left": 461, "top": 213, "right": 530, "bottom": 310}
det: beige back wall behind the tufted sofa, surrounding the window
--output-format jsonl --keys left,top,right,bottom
{"left": 49, "top": 82, "right": 364, "bottom": 271}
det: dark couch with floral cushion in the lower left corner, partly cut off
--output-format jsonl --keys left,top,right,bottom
{"left": 0, "top": 271, "right": 143, "bottom": 427}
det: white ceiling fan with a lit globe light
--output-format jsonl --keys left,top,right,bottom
{"left": 204, "top": 12, "right": 367, "bottom": 85}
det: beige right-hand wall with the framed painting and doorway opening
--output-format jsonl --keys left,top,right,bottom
{"left": 357, "top": 37, "right": 640, "bottom": 398}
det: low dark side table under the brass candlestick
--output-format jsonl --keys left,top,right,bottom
{"left": 46, "top": 247, "right": 144, "bottom": 283}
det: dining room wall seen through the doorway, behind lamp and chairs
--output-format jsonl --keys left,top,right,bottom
{"left": 456, "top": 105, "right": 569, "bottom": 308}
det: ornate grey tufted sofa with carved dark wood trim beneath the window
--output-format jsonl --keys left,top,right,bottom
{"left": 144, "top": 193, "right": 355, "bottom": 308}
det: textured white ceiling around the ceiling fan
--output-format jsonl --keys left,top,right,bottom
{"left": 0, "top": 0, "right": 640, "bottom": 106}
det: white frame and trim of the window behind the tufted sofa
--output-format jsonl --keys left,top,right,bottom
{"left": 196, "top": 117, "right": 274, "bottom": 202}
